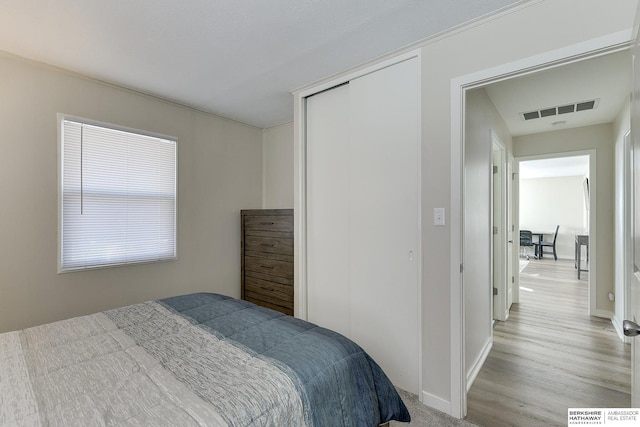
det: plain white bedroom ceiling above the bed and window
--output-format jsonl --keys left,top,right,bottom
{"left": 0, "top": 0, "right": 523, "bottom": 128}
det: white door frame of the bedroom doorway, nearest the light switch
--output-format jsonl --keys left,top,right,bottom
{"left": 449, "top": 31, "right": 632, "bottom": 418}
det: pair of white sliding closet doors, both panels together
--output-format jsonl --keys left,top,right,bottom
{"left": 307, "top": 58, "right": 420, "bottom": 393}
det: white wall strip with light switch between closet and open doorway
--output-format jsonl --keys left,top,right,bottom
{"left": 422, "top": 0, "right": 637, "bottom": 410}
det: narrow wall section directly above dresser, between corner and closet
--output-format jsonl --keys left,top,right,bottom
{"left": 262, "top": 123, "right": 293, "bottom": 209}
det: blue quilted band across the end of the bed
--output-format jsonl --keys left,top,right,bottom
{"left": 158, "top": 293, "right": 410, "bottom": 427}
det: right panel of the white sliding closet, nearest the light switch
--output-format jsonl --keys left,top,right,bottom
{"left": 349, "top": 58, "right": 420, "bottom": 393}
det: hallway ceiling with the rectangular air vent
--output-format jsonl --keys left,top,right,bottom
{"left": 485, "top": 50, "right": 631, "bottom": 136}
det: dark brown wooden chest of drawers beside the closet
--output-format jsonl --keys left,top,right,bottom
{"left": 240, "top": 209, "right": 293, "bottom": 316}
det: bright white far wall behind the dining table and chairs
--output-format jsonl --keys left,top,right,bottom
{"left": 520, "top": 176, "right": 589, "bottom": 259}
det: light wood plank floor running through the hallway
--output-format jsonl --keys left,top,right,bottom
{"left": 467, "top": 259, "right": 631, "bottom": 427}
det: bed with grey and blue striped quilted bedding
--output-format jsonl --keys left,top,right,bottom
{"left": 0, "top": 293, "right": 410, "bottom": 427}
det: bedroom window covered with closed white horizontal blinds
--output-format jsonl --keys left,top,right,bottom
{"left": 59, "top": 116, "right": 177, "bottom": 271}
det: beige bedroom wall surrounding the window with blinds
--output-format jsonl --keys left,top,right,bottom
{"left": 0, "top": 55, "right": 262, "bottom": 332}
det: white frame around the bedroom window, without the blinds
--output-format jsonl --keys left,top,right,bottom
{"left": 57, "top": 113, "right": 178, "bottom": 273}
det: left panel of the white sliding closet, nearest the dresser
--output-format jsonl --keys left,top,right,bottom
{"left": 307, "top": 85, "right": 351, "bottom": 337}
